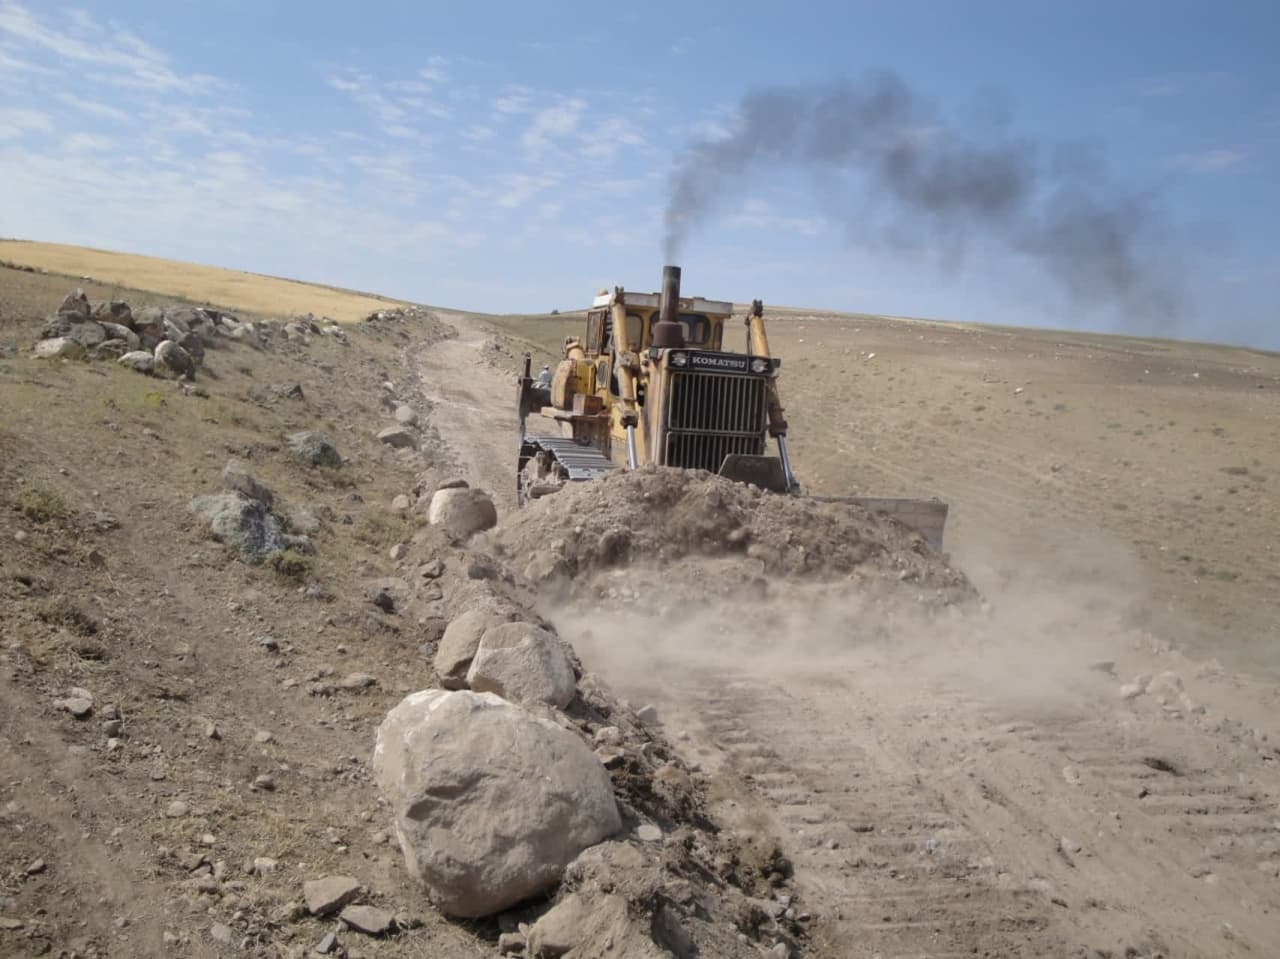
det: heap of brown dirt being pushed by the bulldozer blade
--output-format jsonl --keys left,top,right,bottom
{"left": 495, "top": 467, "right": 973, "bottom": 602}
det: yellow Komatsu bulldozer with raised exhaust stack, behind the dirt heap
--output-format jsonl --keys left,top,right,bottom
{"left": 516, "top": 266, "right": 947, "bottom": 549}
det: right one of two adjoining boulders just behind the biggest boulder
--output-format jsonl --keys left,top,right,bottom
{"left": 467, "top": 622, "right": 576, "bottom": 709}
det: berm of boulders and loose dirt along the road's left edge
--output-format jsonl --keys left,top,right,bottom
{"left": 367, "top": 472, "right": 806, "bottom": 956}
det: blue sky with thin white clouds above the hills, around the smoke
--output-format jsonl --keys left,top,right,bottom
{"left": 0, "top": 0, "right": 1280, "bottom": 348}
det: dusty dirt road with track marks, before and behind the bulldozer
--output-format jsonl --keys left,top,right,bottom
{"left": 424, "top": 311, "right": 1280, "bottom": 956}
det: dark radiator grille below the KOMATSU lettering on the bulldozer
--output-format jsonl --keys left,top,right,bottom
{"left": 666, "top": 373, "right": 768, "bottom": 472}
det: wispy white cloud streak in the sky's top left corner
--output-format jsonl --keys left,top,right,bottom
{"left": 0, "top": 0, "right": 221, "bottom": 93}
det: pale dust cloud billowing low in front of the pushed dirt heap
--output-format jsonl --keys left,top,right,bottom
{"left": 545, "top": 527, "right": 1143, "bottom": 720}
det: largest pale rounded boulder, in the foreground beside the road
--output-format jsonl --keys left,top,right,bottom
{"left": 374, "top": 689, "right": 622, "bottom": 918}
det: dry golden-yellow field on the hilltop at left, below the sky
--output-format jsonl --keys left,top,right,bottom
{"left": 0, "top": 239, "right": 399, "bottom": 323}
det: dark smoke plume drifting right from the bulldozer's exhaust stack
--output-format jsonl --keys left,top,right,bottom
{"left": 664, "top": 73, "right": 1180, "bottom": 326}
